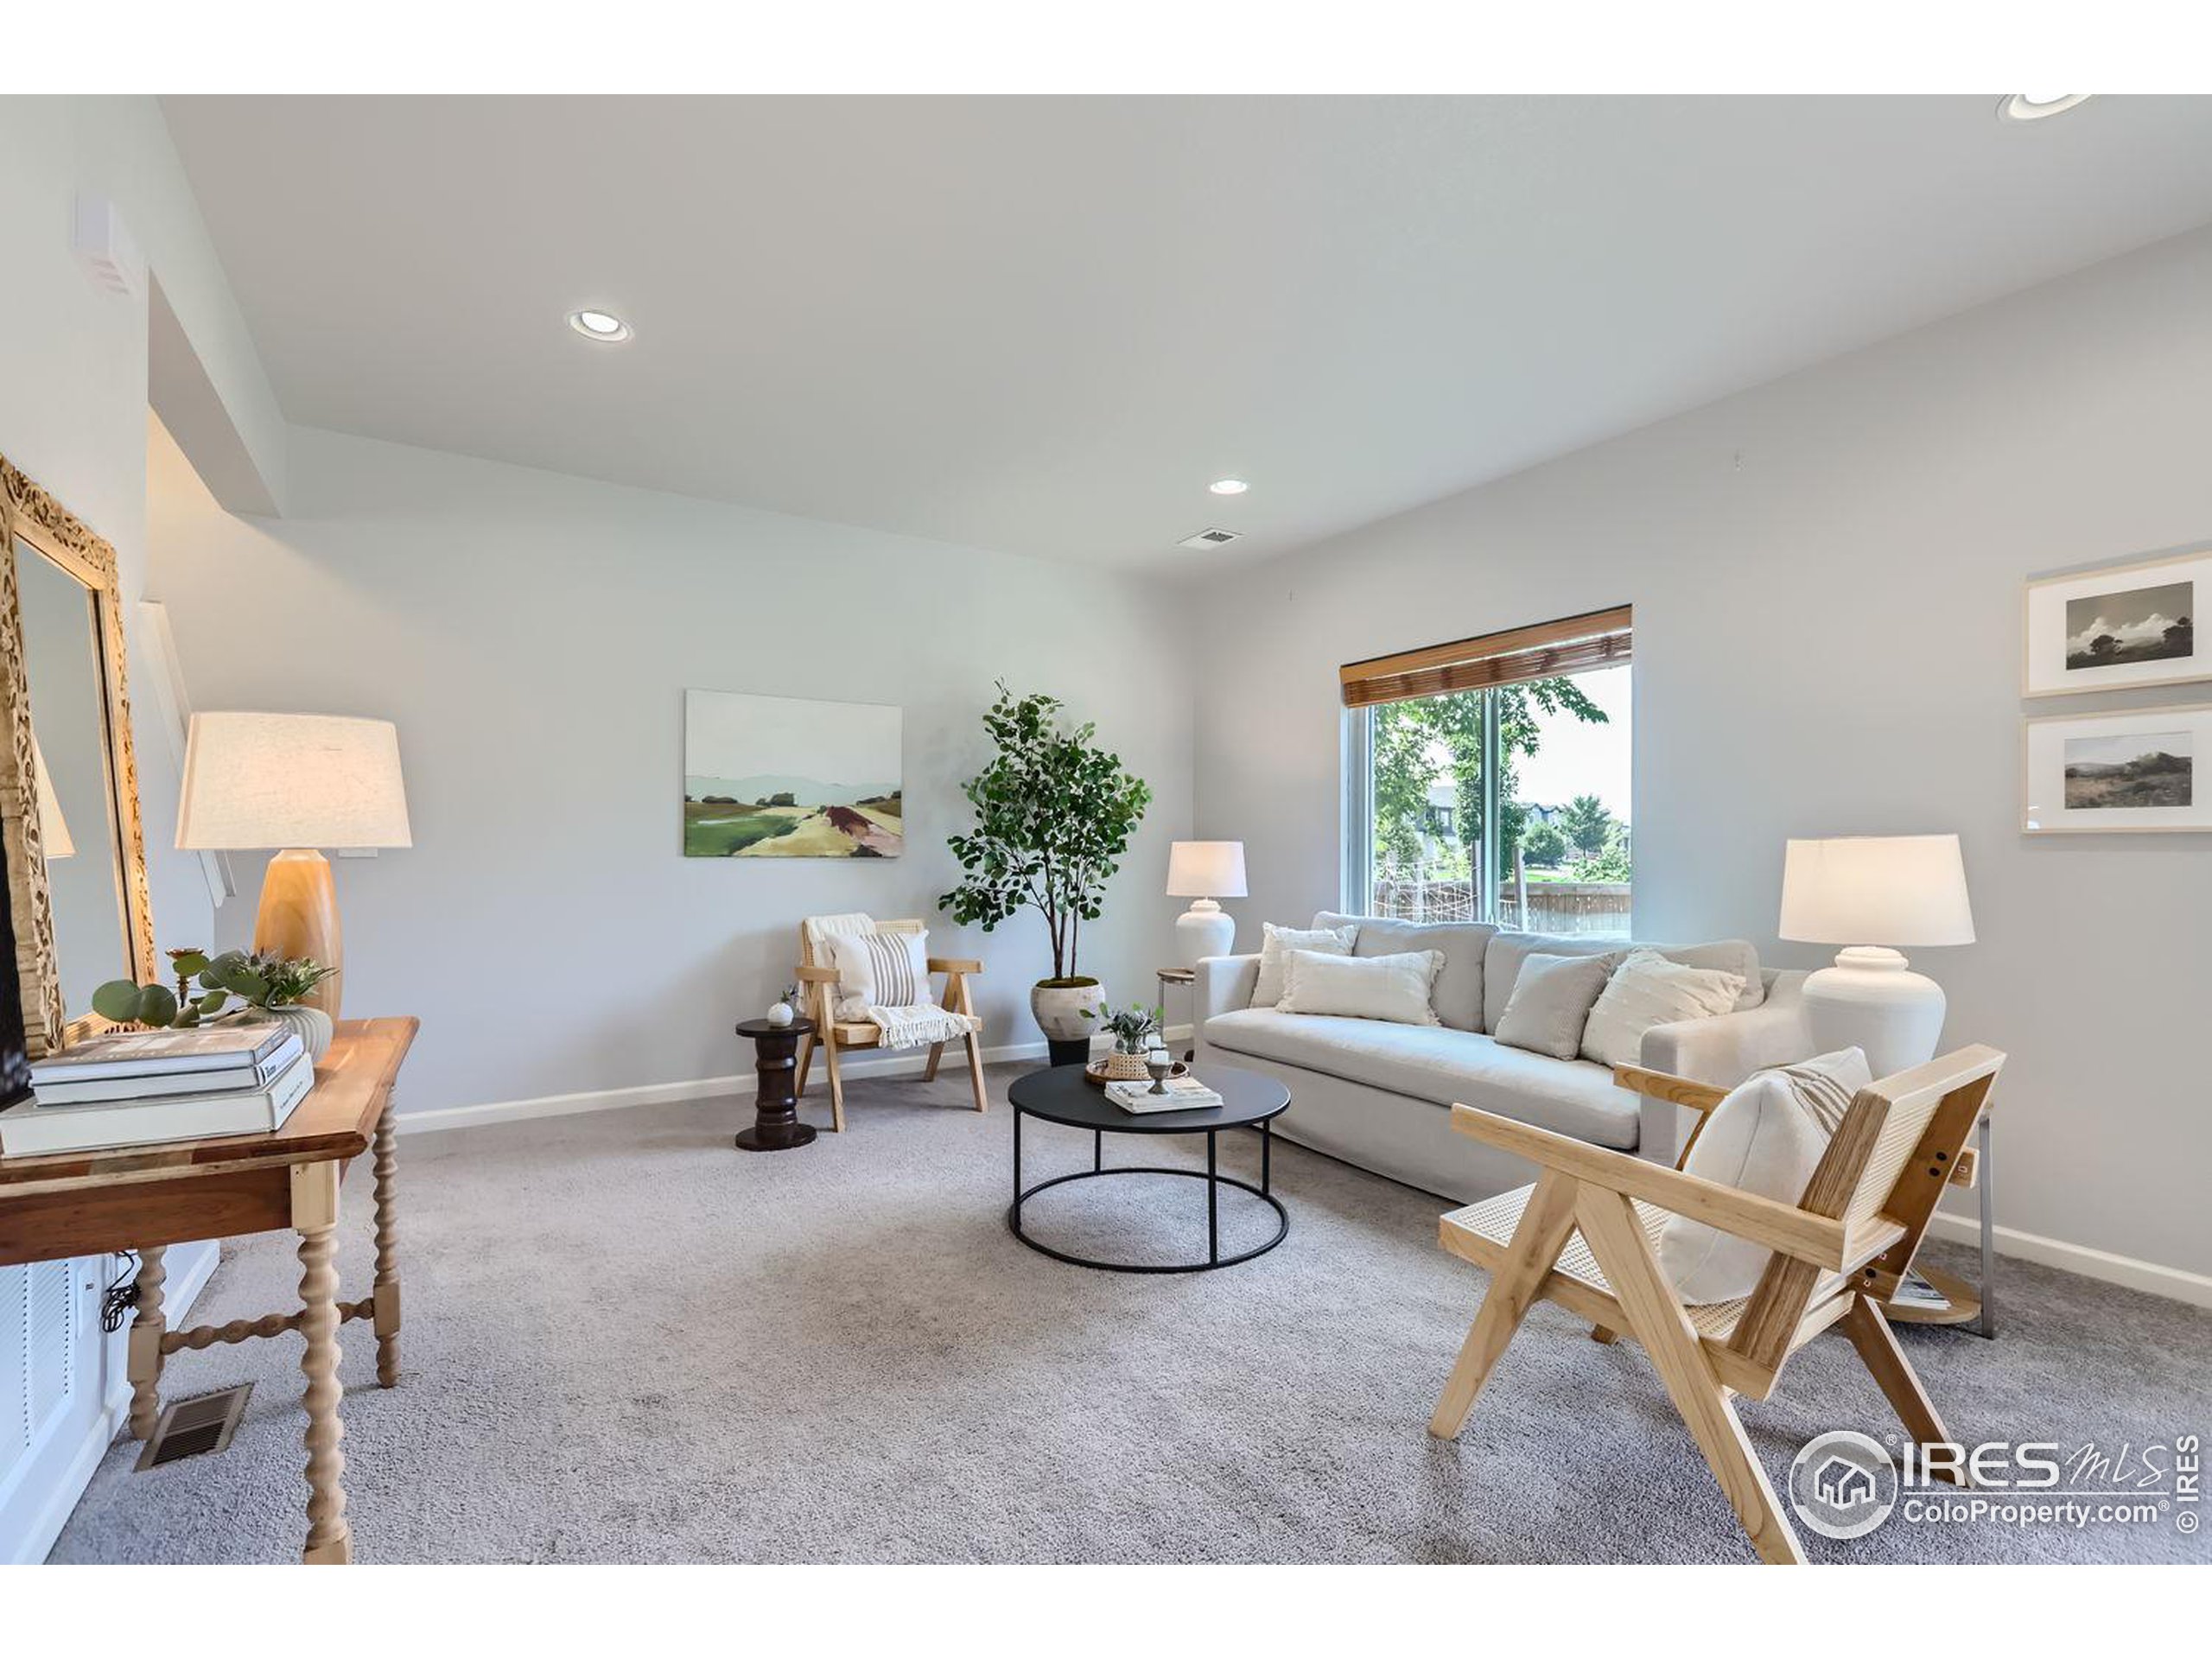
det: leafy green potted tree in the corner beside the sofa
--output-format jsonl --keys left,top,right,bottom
{"left": 938, "top": 681, "right": 1153, "bottom": 1066}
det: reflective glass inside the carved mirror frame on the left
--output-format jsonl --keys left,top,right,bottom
{"left": 13, "top": 537, "right": 130, "bottom": 1020}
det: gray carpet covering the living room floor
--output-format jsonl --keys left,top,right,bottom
{"left": 53, "top": 1071, "right": 2212, "bottom": 1561}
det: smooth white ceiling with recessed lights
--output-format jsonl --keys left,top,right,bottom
{"left": 166, "top": 93, "right": 2212, "bottom": 564}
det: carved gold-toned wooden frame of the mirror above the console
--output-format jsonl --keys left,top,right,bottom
{"left": 0, "top": 455, "right": 155, "bottom": 1059}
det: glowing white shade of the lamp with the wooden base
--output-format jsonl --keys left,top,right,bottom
{"left": 177, "top": 715, "right": 414, "bottom": 852}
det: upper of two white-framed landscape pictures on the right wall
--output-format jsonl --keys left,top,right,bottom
{"left": 2019, "top": 546, "right": 2212, "bottom": 696}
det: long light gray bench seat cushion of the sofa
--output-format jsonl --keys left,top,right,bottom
{"left": 1199, "top": 1008, "right": 1642, "bottom": 1153}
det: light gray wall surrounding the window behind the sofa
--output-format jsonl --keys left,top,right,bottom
{"left": 1197, "top": 232, "right": 2212, "bottom": 1272}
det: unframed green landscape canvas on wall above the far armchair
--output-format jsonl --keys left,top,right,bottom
{"left": 683, "top": 690, "right": 905, "bottom": 858}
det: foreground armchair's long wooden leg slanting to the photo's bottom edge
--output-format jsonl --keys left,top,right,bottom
{"left": 1575, "top": 1185, "right": 1805, "bottom": 1564}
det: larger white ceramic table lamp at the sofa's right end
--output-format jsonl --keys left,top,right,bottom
{"left": 1781, "top": 836, "right": 1974, "bottom": 1077}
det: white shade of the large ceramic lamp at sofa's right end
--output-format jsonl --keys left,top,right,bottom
{"left": 1781, "top": 836, "right": 1974, "bottom": 944}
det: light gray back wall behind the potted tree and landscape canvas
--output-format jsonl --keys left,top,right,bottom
{"left": 150, "top": 429, "right": 1192, "bottom": 1110}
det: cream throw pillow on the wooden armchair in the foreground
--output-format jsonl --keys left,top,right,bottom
{"left": 1659, "top": 1048, "right": 1873, "bottom": 1305}
